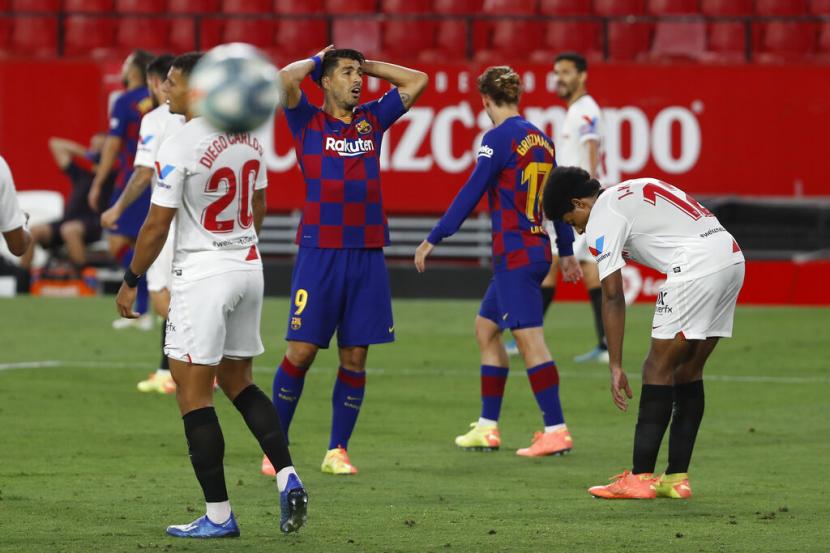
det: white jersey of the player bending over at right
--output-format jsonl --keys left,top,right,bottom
{"left": 585, "top": 179, "right": 744, "bottom": 282}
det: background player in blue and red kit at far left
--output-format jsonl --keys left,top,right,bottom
{"left": 88, "top": 50, "right": 153, "bottom": 330}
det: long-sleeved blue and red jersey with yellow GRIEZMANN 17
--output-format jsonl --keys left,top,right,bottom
{"left": 427, "top": 115, "right": 573, "bottom": 272}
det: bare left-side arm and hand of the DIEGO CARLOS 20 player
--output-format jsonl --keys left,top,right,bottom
{"left": 115, "top": 204, "right": 177, "bottom": 319}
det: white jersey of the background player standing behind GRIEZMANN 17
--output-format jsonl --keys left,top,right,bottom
{"left": 556, "top": 94, "right": 605, "bottom": 182}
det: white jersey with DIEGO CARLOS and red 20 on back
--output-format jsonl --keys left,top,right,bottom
{"left": 152, "top": 117, "right": 268, "bottom": 280}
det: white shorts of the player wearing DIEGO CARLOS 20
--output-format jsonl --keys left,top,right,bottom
{"left": 164, "top": 269, "right": 265, "bottom": 365}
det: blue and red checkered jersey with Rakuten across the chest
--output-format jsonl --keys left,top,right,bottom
{"left": 284, "top": 88, "right": 406, "bottom": 248}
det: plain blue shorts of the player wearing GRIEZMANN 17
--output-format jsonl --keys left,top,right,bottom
{"left": 478, "top": 263, "right": 550, "bottom": 330}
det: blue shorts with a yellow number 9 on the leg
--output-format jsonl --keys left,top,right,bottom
{"left": 285, "top": 247, "right": 395, "bottom": 348}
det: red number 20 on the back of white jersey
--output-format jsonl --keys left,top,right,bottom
{"left": 202, "top": 159, "right": 259, "bottom": 233}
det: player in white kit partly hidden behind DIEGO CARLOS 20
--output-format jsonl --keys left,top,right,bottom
{"left": 101, "top": 54, "right": 184, "bottom": 394}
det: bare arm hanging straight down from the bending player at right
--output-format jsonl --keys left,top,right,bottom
{"left": 602, "top": 269, "right": 633, "bottom": 411}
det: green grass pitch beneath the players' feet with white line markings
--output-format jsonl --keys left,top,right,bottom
{"left": 0, "top": 298, "right": 830, "bottom": 553}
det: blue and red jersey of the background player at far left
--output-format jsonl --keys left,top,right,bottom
{"left": 109, "top": 86, "right": 153, "bottom": 188}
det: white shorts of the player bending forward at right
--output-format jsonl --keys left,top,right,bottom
{"left": 651, "top": 263, "right": 744, "bottom": 340}
